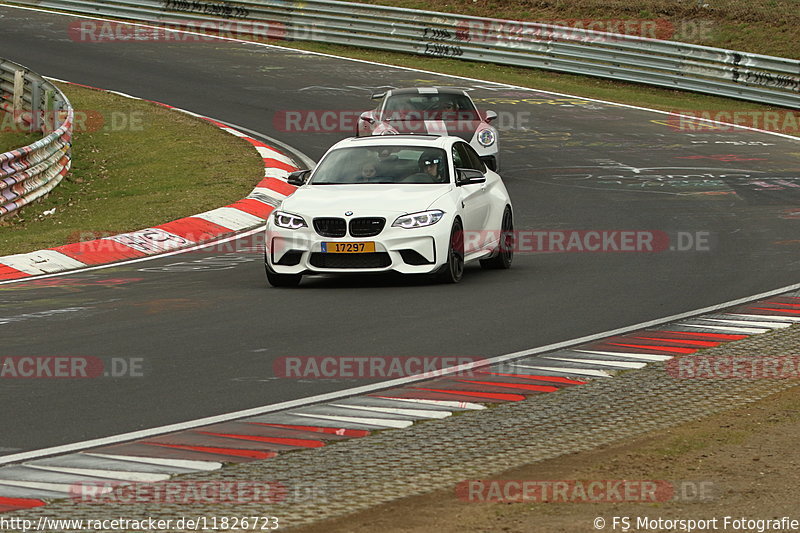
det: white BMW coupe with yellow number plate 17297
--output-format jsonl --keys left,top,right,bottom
{"left": 264, "top": 135, "right": 514, "bottom": 287}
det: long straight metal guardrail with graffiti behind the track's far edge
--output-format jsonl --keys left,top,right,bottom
{"left": 7, "top": 0, "right": 800, "bottom": 108}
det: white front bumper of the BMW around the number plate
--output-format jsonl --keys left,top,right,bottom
{"left": 265, "top": 220, "right": 450, "bottom": 274}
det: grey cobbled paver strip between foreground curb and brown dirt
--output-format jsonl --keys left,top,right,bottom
{"left": 2, "top": 325, "right": 800, "bottom": 531}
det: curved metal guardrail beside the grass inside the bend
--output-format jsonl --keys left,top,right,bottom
{"left": 0, "top": 59, "right": 74, "bottom": 218}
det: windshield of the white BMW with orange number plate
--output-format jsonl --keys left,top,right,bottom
{"left": 310, "top": 145, "right": 450, "bottom": 185}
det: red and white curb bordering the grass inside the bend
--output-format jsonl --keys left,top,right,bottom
{"left": 0, "top": 84, "right": 298, "bottom": 281}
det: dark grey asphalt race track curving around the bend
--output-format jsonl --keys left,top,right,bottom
{"left": 0, "top": 7, "right": 800, "bottom": 455}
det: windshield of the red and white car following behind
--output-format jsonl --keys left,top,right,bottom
{"left": 381, "top": 93, "right": 480, "bottom": 121}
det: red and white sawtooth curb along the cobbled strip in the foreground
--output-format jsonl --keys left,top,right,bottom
{"left": 0, "top": 286, "right": 800, "bottom": 512}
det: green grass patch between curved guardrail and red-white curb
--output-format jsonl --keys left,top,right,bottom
{"left": 0, "top": 85, "right": 264, "bottom": 256}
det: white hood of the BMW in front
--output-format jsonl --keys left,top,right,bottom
{"left": 280, "top": 183, "right": 452, "bottom": 217}
